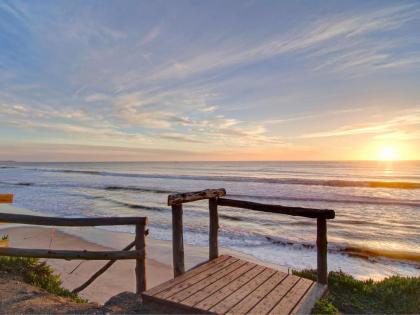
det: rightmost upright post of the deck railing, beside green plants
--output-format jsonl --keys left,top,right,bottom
{"left": 316, "top": 218, "right": 328, "bottom": 284}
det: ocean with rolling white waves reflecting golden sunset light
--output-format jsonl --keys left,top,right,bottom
{"left": 0, "top": 161, "right": 420, "bottom": 279}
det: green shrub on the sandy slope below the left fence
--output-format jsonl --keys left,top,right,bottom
{"left": 0, "top": 256, "right": 86, "bottom": 303}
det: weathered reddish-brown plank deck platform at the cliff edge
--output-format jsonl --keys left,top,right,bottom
{"left": 142, "top": 255, "right": 326, "bottom": 314}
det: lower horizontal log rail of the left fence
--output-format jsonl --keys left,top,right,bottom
{"left": 0, "top": 247, "right": 144, "bottom": 260}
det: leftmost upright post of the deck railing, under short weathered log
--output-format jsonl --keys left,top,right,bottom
{"left": 172, "top": 204, "right": 185, "bottom": 277}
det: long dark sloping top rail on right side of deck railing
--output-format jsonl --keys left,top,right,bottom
{"left": 217, "top": 198, "right": 335, "bottom": 219}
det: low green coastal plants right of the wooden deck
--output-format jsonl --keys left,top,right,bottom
{"left": 294, "top": 270, "right": 420, "bottom": 314}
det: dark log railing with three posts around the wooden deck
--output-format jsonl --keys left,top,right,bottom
{"left": 168, "top": 188, "right": 335, "bottom": 284}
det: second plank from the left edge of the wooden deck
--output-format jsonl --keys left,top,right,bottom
{"left": 154, "top": 257, "right": 239, "bottom": 299}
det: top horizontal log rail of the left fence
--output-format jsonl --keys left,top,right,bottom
{"left": 0, "top": 213, "right": 147, "bottom": 226}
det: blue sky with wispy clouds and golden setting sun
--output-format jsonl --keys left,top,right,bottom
{"left": 0, "top": 0, "right": 420, "bottom": 161}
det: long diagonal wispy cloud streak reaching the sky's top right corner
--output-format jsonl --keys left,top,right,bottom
{"left": 152, "top": 4, "right": 420, "bottom": 79}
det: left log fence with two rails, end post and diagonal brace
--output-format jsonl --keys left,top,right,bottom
{"left": 0, "top": 213, "right": 147, "bottom": 294}
